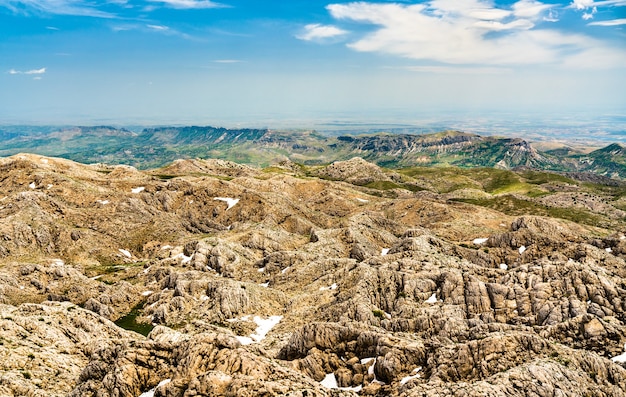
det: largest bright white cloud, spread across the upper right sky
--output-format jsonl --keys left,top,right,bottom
{"left": 327, "top": 0, "right": 624, "bottom": 67}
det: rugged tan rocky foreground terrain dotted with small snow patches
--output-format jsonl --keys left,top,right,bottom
{"left": 0, "top": 154, "right": 626, "bottom": 397}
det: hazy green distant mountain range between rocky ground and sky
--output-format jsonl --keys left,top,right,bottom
{"left": 0, "top": 126, "right": 626, "bottom": 179}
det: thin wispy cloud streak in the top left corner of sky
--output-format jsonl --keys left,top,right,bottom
{"left": 0, "top": 0, "right": 116, "bottom": 18}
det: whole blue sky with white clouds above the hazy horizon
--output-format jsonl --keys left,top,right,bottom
{"left": 0, "top": 0, "right": 626, "bottom": 127}
